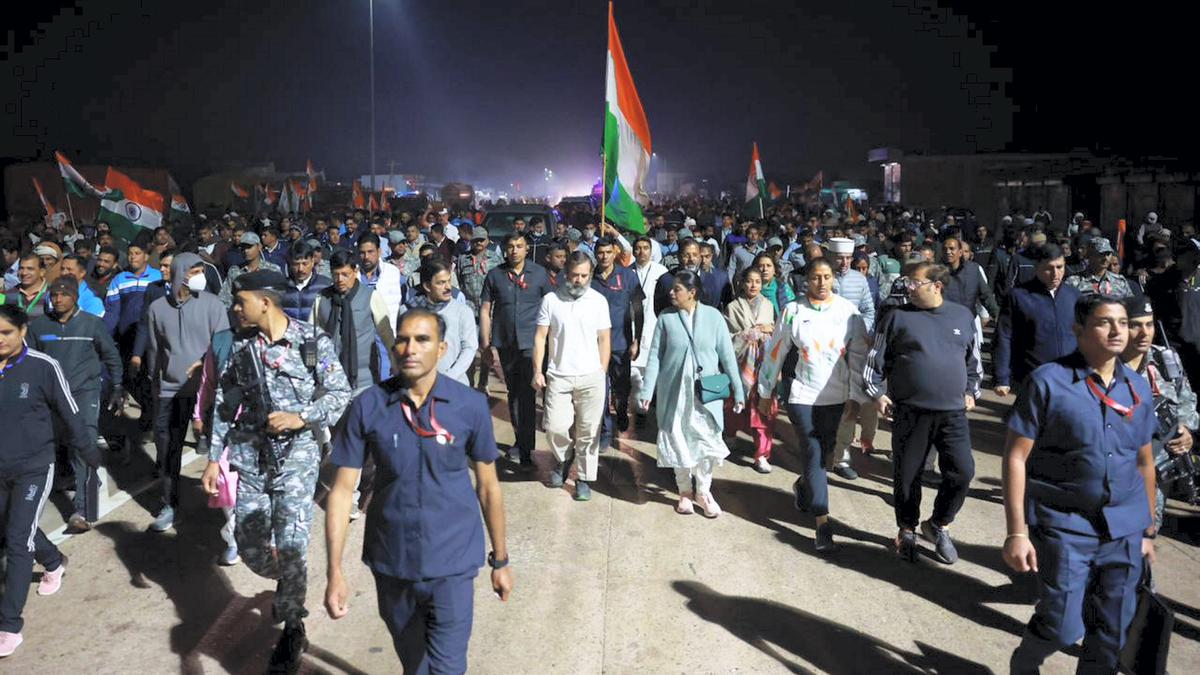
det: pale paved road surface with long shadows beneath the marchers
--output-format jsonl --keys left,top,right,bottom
{"left": 11, "top": 386, "right": 1200, "bottom": 675}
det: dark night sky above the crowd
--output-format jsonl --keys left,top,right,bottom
{"left": 0, "top": 0, "right": 1200, "bottom": 192}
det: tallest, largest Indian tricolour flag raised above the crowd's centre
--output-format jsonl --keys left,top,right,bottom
{"left": 604, "top": 2, "right": 650, "bottom": 233}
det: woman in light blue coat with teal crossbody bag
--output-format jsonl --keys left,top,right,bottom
{"left": 637, "top": 270, "right": 745, "bottom": 518}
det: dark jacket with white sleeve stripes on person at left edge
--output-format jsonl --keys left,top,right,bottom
{"left": 0, "top": 347, "right": 93, "bottom": 476}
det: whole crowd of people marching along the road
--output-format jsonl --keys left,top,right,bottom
{"left": 0, "top": 193, "right": 1200, "bottom": 673}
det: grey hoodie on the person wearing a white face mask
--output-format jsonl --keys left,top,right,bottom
{"left": 146, "top": 253, "right": 229, "bottom": 395}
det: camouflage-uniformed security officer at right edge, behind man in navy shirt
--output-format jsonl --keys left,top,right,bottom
{"left": 1121, "top": 297, "right": 1200, "bottom": 531}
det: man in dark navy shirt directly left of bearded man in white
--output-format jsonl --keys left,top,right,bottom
{"left": 479, "top": 232, "right": 553, "bottom": 471}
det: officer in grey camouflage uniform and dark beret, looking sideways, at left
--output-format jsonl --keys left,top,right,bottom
{"left": 202, "top": 270, "right": 350, "bottom": 674}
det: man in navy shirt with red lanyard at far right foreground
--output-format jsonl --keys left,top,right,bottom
{"left": 1002, "top": 294, "right": 1156, "bottom": 673}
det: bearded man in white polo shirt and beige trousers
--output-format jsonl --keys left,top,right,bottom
{"left": 533, "top": 251, "right": 612, "bottom": 502}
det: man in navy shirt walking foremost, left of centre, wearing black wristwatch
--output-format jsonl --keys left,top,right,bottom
{"left": 325, "top": 307, "right": 513, "bottom": 673}
